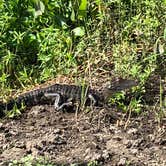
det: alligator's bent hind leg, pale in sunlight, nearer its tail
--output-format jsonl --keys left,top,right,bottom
{"left": 44, "top": 93, "right": 72, "bottom": 111}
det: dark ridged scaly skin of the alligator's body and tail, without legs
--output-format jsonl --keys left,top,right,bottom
{"left": 0, "top": 84, "right": 103, "bottom": 110}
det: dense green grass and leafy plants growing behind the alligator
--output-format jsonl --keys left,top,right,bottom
{"left": 0, "top": 0, "right": 166, "bottom": 115}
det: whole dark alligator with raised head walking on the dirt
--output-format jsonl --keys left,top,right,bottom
{"left": 0, "top": 79, "right": 137, "bottom": 114}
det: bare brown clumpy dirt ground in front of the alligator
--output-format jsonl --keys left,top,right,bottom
{"left": 0, "top": 105, "right": 166, "bottom": 166}
